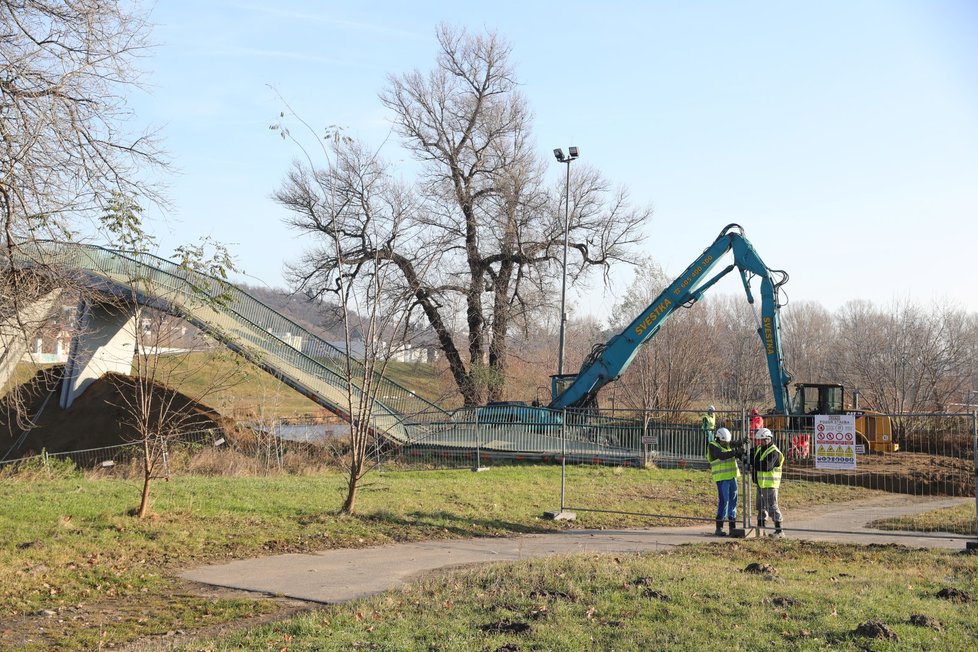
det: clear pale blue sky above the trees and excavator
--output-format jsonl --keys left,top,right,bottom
{"left": 131, "top": 0, "right": 978, "bottom": 318}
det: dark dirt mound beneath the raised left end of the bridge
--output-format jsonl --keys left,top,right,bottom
{"left": 0, "top": 367, "right": 229, "bottom": 457}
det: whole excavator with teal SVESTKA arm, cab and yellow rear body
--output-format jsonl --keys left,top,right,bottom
{"left": 548, "top": 224, "right": 897, "bottom": 451}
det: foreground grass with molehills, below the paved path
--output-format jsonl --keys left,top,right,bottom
{"left": 182, "top": 541, "right": 978, "bottom": 652}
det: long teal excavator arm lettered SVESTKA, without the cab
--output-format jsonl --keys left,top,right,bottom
{"left": 550, "top": 224, "right": 791, "bottom": 413}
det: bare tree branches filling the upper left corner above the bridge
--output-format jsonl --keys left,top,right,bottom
{"left": 0, "top": 0, "right": 163, "bottom": 428}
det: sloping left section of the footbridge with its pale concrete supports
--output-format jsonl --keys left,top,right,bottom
{"left": 0, "top": 242, "right": 448, "bottom": 443}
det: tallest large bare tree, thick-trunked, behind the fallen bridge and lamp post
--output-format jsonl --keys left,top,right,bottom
{"left": 276, "top": 27, "right": 651, "bottom": 405}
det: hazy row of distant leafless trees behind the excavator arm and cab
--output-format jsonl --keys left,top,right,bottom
{"left": 571, "top": 290, "right": 978, "bottom": 413}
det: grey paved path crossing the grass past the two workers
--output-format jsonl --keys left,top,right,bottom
{"left": 181, "top": 496, "right": 974, "bottom": 603}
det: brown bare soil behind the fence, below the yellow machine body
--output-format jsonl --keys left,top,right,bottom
{"left": 785, "top": 451, "right": 975, "bottom": 496}
